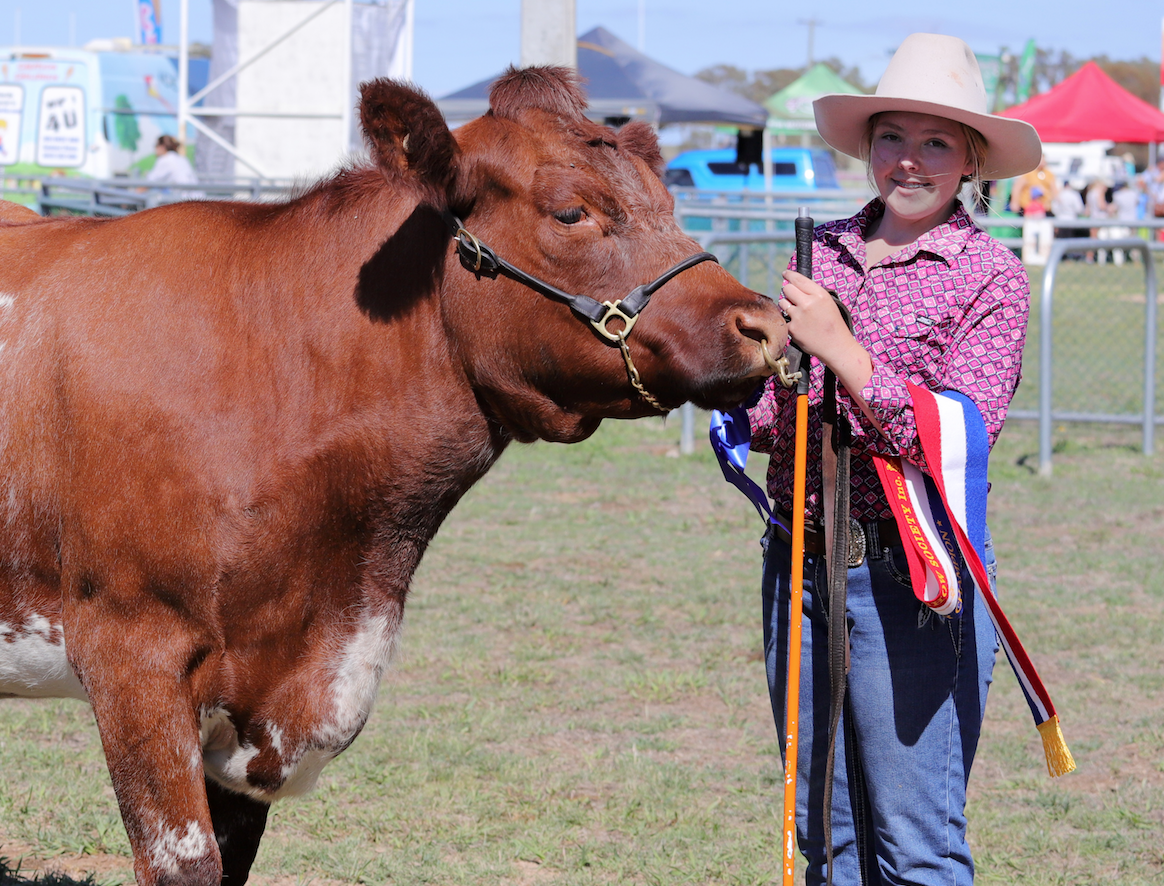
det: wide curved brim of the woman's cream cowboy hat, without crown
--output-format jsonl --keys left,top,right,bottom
{"left": 812, "top": 93, "right": 1043, "bottom": 180}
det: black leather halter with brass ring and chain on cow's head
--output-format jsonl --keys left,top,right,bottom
{"left": 445, "top": 213, "right": 719, "bottom": 412}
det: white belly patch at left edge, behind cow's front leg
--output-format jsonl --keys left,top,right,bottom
{"left": 0, "top": 615, "right": 88, "bottom": 702}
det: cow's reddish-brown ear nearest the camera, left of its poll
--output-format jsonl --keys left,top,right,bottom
{"left": 360, "top": 79, "right": 457, "bottom": 194}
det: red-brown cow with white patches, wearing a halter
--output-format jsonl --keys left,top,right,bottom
{"left": 0, "top": 68, "right": 787, "bottom": 886}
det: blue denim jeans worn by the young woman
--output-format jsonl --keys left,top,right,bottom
{"left": 762, "top": 533, "right": 998, "bottom": 886}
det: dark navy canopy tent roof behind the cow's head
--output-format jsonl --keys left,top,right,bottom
{"left": 437, "top": 27, "right": 768, "bottom": 128}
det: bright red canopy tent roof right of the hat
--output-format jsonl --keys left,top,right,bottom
{"left": 1001, "top": 62, "right": 1164, "bottom": 144}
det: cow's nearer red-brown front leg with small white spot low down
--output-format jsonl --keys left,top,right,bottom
{"left": 65, "top": 572, "right": 222, "bottom": 886}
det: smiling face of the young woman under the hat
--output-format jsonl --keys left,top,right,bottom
{"left": 870, "top": 111, "right": 974, "bottom": 231}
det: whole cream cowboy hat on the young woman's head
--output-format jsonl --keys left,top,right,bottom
{"left": 812, "top": 34, "right": 1043, "bottom": 180}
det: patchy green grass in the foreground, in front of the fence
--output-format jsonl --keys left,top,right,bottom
{"left": 0, "top": 405, "right": 1164, "bottom": 886}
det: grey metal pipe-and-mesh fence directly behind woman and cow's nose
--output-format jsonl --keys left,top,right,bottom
{"left": 680, "top": 212, "right": 1164, "bottom": 475}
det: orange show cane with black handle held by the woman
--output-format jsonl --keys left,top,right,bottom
{"left": 783, "top": 206, "right": 812, "bottom": 886}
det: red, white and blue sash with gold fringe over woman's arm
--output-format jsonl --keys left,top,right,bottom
{"left": 873, "top": 384, "right": 1076, "bottom": 777}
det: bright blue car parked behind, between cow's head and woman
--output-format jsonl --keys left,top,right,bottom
{"left": 665, "top": 148, "right": 838, "bottom": 191}
